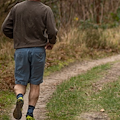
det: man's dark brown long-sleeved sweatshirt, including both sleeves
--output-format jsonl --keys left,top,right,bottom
{"left": 2, "top": 1, "right": 57, "bottom": 49}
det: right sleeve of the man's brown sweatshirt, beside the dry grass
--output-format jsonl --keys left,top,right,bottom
{"left": 46, "top": 7, "right": 57, "bottom": 44}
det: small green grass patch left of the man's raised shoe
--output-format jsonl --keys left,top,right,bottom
{"left": 0, "top": 91, "right": 15, "bottom": 120}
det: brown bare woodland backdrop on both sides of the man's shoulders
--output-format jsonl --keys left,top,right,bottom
{"left": 0, "top": 0, "right": 120, "bottom": 26}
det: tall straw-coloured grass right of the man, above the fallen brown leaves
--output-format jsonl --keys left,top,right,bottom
{"left": 59, "top": 27, "right": 120, "bottom": 51}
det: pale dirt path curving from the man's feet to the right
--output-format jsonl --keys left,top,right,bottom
{"left": 11, "top": 55, "right": 120, "bottom": 120}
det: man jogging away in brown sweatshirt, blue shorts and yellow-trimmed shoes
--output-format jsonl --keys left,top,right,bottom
{"left": 2, "top": 0, "right": 57, "bottom": 120}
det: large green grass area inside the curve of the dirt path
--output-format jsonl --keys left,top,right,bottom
{"left": 47, "top": 64, "right": 120, "bottom": 120}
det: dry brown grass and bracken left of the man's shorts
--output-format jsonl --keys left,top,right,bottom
{"left": 0, "top": 35, "right": 14, "bottom": 89}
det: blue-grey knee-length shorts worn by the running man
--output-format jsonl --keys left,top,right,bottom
{"left": 14, "top": 47, "right": 46, "bottom": 86}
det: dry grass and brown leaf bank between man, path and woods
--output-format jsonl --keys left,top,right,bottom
{"left": 47, "top": 27, "right": 120, "bottom": 67}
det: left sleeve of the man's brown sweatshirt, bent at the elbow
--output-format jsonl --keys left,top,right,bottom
{"left": 1, "top": 9, "right": 13, "bottom": 39}
